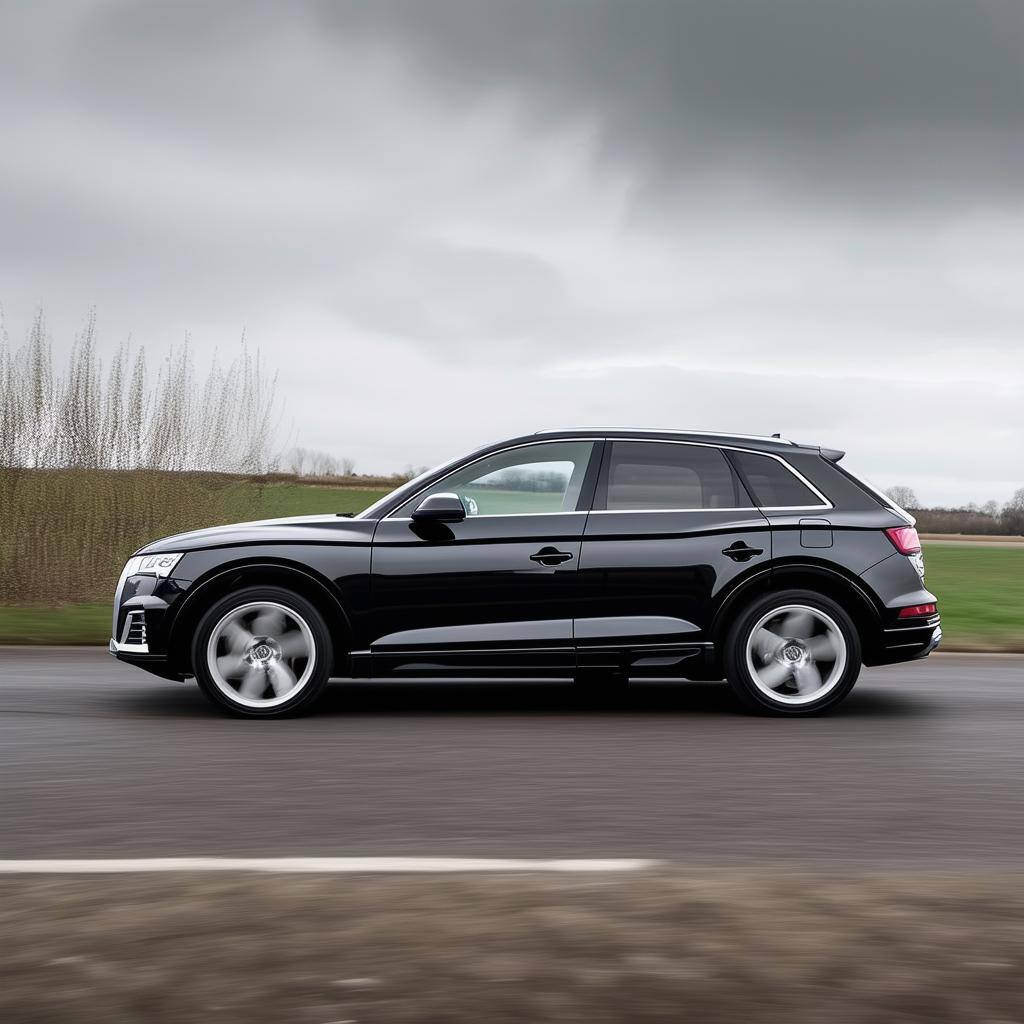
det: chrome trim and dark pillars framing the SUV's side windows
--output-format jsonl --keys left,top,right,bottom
{"left": 382, "top": 436, "right": 836, "bottom": 522}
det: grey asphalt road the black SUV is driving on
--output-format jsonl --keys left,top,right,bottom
{"left": 0, "top": 648, "right": 1024, "bottom": 869}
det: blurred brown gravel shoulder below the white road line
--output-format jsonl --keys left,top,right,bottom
{"left": 6, "top": 869, "right": 1024, "bottom": 1024}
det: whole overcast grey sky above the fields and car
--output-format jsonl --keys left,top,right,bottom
{"left": 0, "top": 0, "right": 1024, "bottom": 504}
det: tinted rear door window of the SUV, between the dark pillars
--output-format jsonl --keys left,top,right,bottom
{"left": 604, "top": 441, "right": 751, "bottom": 512}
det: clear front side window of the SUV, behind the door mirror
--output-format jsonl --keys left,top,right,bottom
{"left": 394, "top": 441, "right": 594, "bottom": 516}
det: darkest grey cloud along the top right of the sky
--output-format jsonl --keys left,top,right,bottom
{"left": 322, "top": 0, "right": 1024, "bottom": 203}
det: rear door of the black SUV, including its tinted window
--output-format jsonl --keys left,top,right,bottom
{"left": 574, "top": 440, "right": 771, "bottom": 677}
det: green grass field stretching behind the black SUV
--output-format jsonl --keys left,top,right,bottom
{"left": 0, "top": 483, "right": 1024, "bottom": 651}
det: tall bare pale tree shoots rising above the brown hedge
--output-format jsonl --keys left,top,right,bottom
{"left": 0, "top": 313, "right": 281, "bottom": 473}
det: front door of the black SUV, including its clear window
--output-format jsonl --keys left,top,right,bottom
{"left": 371, "top": 440, "right": 596, "bottom": 680}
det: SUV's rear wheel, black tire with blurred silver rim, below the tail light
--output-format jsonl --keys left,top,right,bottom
{"left": 725, "top": 590, "right": 861, "bottom": 715}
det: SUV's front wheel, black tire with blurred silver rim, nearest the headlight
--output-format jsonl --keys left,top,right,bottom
{"left": 193, "top": 587, "right": 334, "bottom": 718}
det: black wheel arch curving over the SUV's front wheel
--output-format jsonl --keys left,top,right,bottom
{"left": 167, "top": 558, "right": 352, "bottom": 674}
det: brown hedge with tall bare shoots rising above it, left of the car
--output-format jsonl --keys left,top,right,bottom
{"left": 0, "top": 315, "right": 281, "bottom": 605}
